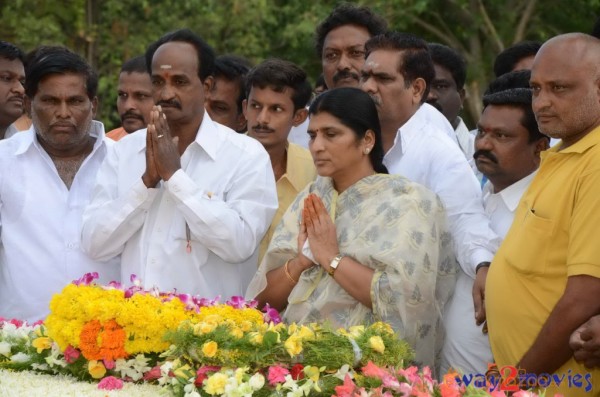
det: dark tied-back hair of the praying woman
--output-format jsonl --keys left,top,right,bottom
{"left": 308, "top": 87, "right": 389, "bottom": 174}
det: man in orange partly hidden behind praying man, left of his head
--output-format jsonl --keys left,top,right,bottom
{"left": 106, "top": 56, "right": 154, "bottom": 141}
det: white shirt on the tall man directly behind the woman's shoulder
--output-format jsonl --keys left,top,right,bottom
{"left": 383, "top": 106, "right": 500, "bottom": 278}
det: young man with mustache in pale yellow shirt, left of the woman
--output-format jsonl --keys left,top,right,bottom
{"left": 243, "top": 59, "right": 317, "bottom": 263}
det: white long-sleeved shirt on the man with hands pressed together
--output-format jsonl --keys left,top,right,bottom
{"left": 82, "top": 112, "right": 277, "bottom": 299}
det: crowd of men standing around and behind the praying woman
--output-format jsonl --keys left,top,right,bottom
{"left": 0, "top": 4, "right": 600, "bottom": 396}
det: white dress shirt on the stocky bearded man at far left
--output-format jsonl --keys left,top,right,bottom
{"left": 0, "top": 121, "right": 120, "bottom": 322}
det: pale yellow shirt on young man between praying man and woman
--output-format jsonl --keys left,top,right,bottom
{"left": 258, "top": 143, "right": 317, "bottom": 265}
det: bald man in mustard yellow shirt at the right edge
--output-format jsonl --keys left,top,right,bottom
{"left": 486, "top": 33, "right": 600, "bottom": 396}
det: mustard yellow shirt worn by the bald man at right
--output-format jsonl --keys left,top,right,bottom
{"left": 486, "top": 127, "right": 600, "bottom": 396}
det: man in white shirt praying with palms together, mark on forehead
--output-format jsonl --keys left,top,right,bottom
{"left": 82, "top": 29, "right": 277, "bottom": 298}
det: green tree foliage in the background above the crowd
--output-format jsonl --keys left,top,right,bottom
{"left": 0, "top": 0, "right": 600, "bottom": 130}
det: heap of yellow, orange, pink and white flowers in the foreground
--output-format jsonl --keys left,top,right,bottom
{"left": 0, "top": 274, "right": 564, "bottom": 397}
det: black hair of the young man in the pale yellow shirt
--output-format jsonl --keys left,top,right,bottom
{"left": 246, "top": 58, "right": 312, "bottom": 111}
